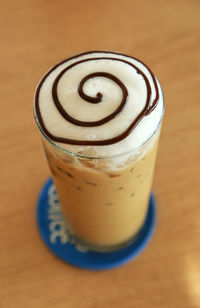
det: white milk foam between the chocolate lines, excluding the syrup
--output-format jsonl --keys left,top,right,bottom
{"left": 35, "top": 52, "right": 163, "bottom": 157}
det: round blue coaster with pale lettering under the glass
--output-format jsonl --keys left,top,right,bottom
{"left": 37, "top": 178, "right": 156, "bottom": 270}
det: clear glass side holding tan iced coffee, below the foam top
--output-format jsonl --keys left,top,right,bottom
{"left": 34, "top": 88, "right": 164, "bottom": 252}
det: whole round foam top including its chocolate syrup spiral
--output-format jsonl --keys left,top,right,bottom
{"left": 35, "top": 51, "right": 163, "bottom": 157}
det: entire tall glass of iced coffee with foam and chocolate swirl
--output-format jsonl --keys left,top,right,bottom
{"left": 34, "top": 51, "right": 163, "bottom": 251}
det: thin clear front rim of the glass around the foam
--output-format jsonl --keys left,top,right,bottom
{"left": 33, "top": 77, "right": 165, "bottom": 160}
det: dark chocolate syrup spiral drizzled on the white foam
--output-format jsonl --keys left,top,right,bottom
{"left": 35, "top": 51, "right": 159, "bottom": 146}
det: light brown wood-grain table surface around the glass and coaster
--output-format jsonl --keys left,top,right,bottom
{"left": 0, "top": 0, "right": 200, "bottom": 308}
